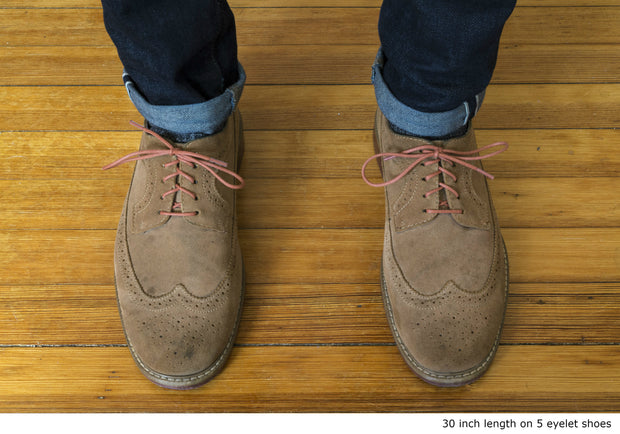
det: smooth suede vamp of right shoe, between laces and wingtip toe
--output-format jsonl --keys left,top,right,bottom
{"left": 392, "top": 214, "right": 494, "bottom": 295}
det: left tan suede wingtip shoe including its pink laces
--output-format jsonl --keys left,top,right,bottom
{"left": 106, "top": 113, "right": 244, "bottom": 389}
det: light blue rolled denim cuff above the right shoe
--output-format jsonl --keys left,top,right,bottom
{"left": 372, "top": 49, "right": 485, "bottom": 137}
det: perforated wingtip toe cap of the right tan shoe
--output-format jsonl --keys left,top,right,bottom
{"left": 388, "top": 276, "right": 505, "bottom": 383}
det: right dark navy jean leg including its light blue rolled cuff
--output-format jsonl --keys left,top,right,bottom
{"left": 373, "top": 0, "right": 515, "bottom": 135}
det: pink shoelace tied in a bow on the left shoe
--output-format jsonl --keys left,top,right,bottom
{"left": 103, "top": 121, "right": 245, "bottom": 217}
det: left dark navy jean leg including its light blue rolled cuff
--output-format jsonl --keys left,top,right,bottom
{"left": 102, "top": 0, "right": 245, "bottom": 142}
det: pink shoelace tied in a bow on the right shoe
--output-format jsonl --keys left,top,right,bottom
{"left": 362, "top": 142, "right": 508, "bottom": 214}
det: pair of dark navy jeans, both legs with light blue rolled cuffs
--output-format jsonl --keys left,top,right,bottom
{"left": 102, "top": 0, "right": 516, "bottom": 136}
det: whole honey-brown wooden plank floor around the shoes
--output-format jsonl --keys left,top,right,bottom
{"left": 0, "top": 0, "right": 620, "bottom": 412}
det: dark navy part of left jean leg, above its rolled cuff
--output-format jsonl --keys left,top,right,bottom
{"left": 102, "top": 0, "right": 239, "bottom": 105}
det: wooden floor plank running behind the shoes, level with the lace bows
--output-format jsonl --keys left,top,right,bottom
{"left": 0, "top": 131, "right": 620, "bottom": 181}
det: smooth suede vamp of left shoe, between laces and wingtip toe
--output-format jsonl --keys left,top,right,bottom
{"left": 127, "top": 217, "right": 232, "bottom": 297}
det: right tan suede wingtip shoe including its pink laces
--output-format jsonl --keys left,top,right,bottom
{"left": 363, "top": 112, "right": 508, "bottom": 386}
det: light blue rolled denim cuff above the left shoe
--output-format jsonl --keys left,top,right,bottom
{"left": 123, "top": 64, "right": 245, "bottom": 134}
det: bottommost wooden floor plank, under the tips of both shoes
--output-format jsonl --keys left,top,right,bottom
{"left": 0, "top": 346, "right": 620, "bottom": 412}
